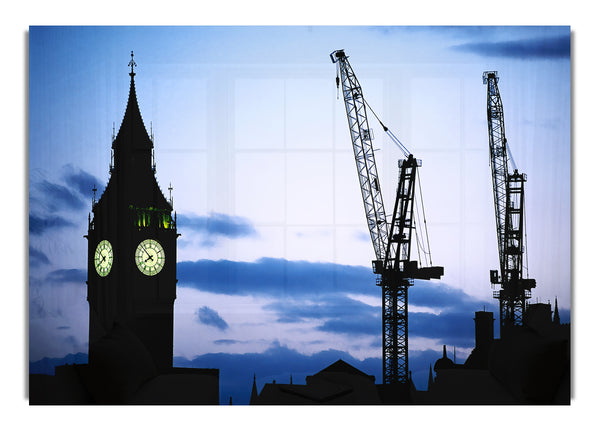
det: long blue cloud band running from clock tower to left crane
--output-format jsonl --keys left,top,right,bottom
{"left": 177, "top": 257, "right": 378, "bottom": 299}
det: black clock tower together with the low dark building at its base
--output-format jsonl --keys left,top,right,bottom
{"left": 30, "top": 52, "right": 219, "bottom": 404}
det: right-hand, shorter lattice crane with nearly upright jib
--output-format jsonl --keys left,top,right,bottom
{"left": 483, "top": 72, "right": 535, "bottom": 338}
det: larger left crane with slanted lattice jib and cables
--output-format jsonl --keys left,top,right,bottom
{"left": 330, "top": 50, "right": 444, "bottom": 388}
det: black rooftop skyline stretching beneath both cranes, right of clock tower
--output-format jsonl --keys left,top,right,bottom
{"left": 250, "top": 301, "right": 571, "bottom": 405}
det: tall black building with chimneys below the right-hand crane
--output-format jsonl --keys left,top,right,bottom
{"left": 412, "top": 301, "right": 571, "bottom": 404}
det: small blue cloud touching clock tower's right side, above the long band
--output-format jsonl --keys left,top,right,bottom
{"left": 177, "top": 213, "right": 257, "bottom": 246}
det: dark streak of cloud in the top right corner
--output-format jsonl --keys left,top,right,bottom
{"left": 452, "top": 35, "right": 571, "bottom": 59}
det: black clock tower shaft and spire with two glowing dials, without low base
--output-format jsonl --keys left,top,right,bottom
{"left": 86, "top": 52, "right": 178, "bottom": 371}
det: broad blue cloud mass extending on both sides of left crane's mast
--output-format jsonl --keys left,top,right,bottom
{"left": 178, "top": 258, "right": 494, "bottom": 347}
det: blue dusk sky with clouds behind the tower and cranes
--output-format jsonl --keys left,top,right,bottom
{"left": 28, "top": 26, "right": 572, "bottom": 404}
